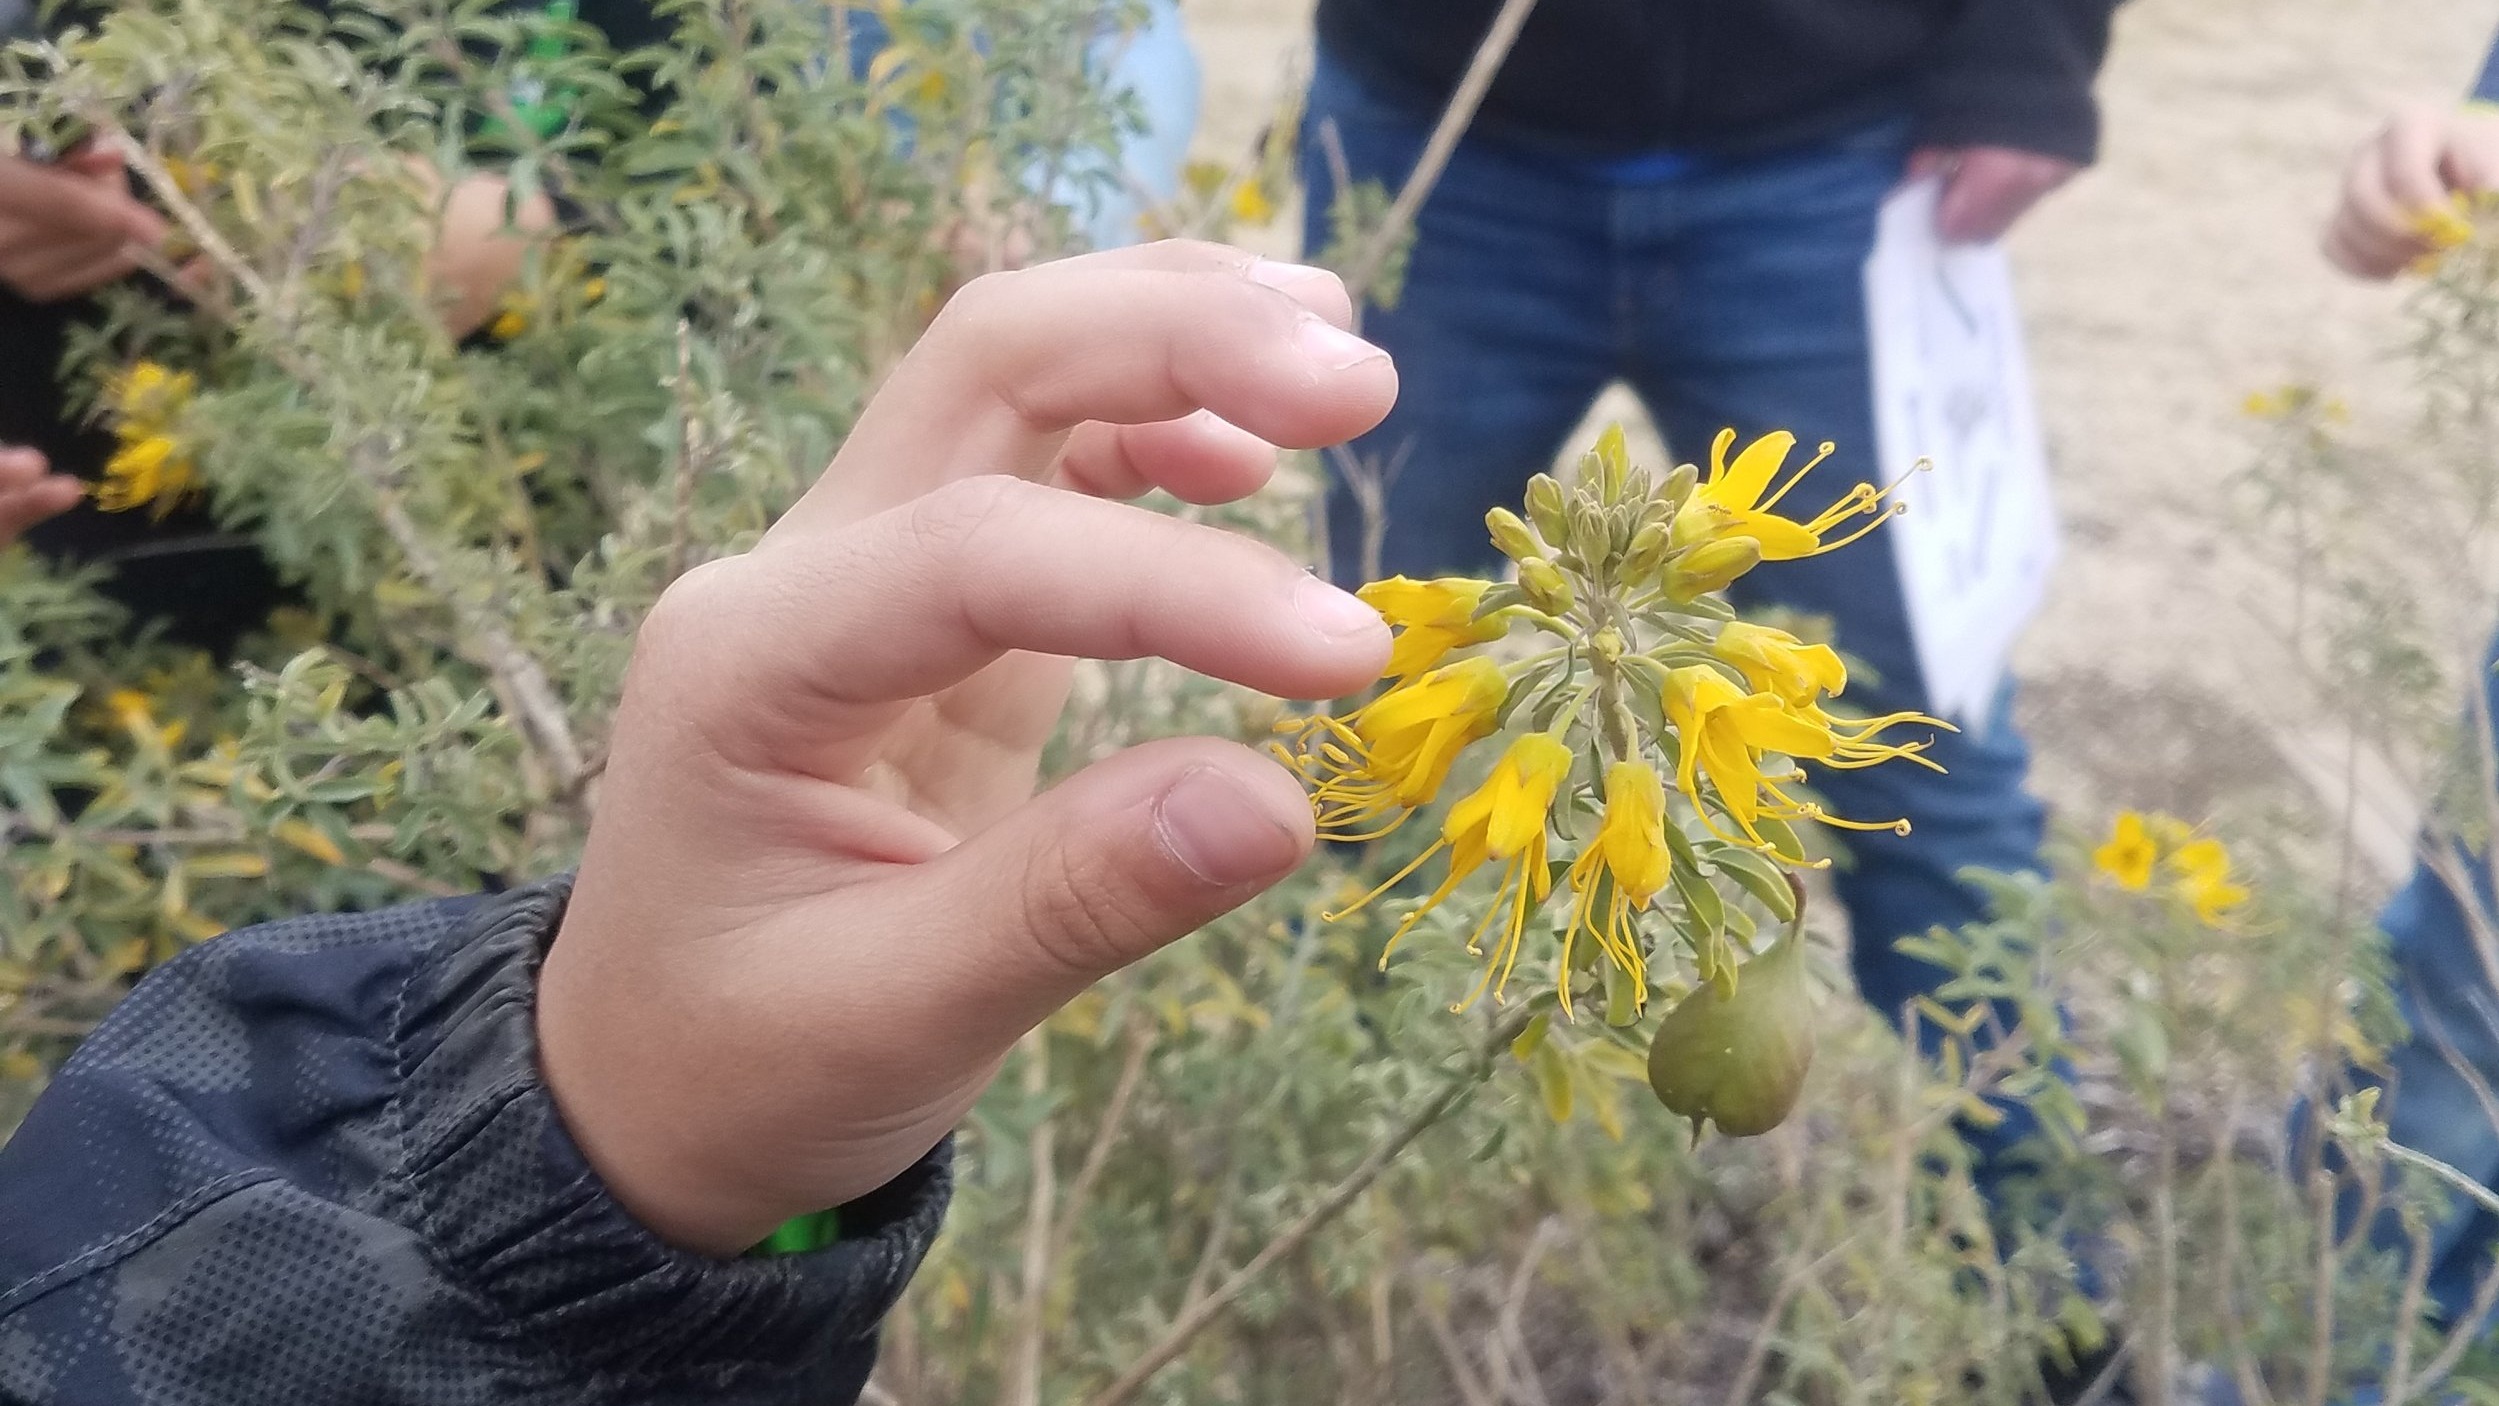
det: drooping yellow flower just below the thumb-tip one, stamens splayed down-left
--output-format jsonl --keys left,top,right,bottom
{"left": 1327, "top": 732, "right": 1572, "bottom": 1006}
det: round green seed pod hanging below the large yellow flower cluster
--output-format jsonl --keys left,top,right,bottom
{"left": 1649, "top": 932, "right": 1814, "bottom": 1141}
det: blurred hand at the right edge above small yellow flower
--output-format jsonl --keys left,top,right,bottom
{"left": 2324, "top": 102, "right": 2499, "bottom": 277}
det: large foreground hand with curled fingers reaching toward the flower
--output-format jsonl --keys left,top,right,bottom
{"left": 540, "top": 242, "right": 1397, "bottom": 1254}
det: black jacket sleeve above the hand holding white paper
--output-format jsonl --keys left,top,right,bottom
{"left": 1919, "top": 0, "right": 2119, "bottom": 165}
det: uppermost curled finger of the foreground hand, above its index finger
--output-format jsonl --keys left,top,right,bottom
{"left": 775, "top": 245, "right": 1397, "bottom": 532}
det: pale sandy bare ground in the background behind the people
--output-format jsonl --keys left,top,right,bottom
{"left": 1185, "top": 0, "right": 2499, "bottom": 877}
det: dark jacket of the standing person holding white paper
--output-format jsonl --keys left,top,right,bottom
{"left": 1319, "top": 0, "right": 2117, "bottom": 162}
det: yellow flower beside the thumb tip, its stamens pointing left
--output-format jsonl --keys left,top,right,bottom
{"left": 1279, "top": 659, "right": 1509, "bottom": 839}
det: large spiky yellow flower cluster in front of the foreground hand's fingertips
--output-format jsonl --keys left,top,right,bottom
{"left": 1277, "top": 430, "right": 1944, "bottom": 1011}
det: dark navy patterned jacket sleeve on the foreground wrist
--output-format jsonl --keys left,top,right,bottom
{"left": 0, "top": 882, "right": 950, "bottom": 1406}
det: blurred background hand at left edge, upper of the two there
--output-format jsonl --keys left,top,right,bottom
{"left": 0, "top": 142, "right": 167, "bottom": 302}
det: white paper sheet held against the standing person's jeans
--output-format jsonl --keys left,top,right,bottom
{"left": 1869, "top": 180, "right": 2057, "bottom": 727}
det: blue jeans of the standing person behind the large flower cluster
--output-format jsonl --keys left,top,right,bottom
{"left": 1302, "top": 55, "right": 2044, "bottom": 1168}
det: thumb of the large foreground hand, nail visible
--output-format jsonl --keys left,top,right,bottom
{"left": 915, "top": 737, "right": 1314, "bottom": 1023}
